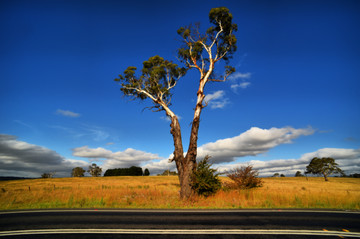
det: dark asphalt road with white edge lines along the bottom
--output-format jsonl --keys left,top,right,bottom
{"left": 0, "top": 209, "right": 360, "bottom": 239}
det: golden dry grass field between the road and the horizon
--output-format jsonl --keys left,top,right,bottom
{"left": 0, "top": 176, "right": 360, "bottom": 210}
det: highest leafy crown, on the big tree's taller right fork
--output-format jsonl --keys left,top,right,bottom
{"left": 177, "top": 7, "right": 237, "bottom": 78}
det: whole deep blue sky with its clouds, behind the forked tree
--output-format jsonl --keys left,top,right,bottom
{"left": 0, "top": 0, "right": 360, "bottom": 177}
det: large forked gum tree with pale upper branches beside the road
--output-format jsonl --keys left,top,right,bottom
{"left": 115, "top": 7, "right": 237, "bottom": 199}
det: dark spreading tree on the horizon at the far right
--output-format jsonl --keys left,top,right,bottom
{"left": 305, "top": 158, "right": 344, "bottom": 181}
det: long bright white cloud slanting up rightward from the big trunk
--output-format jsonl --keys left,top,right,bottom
{"left": 198, "top": 127, "right": 314, "bottom": 163}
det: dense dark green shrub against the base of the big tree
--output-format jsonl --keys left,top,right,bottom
{"left": 191, "top": 155, "right": 221, "bottom": 197}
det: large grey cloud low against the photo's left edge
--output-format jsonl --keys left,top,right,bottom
{"left": 0, "top": 134, "right": 89, "bottom": 177}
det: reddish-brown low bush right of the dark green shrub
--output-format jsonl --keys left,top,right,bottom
{"left": 226, "top": 165, "right": 263, "bottom": 189}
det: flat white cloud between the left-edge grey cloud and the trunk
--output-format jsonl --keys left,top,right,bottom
{"left": 73, "top": 146, "right": 161, "bottom": 171}
